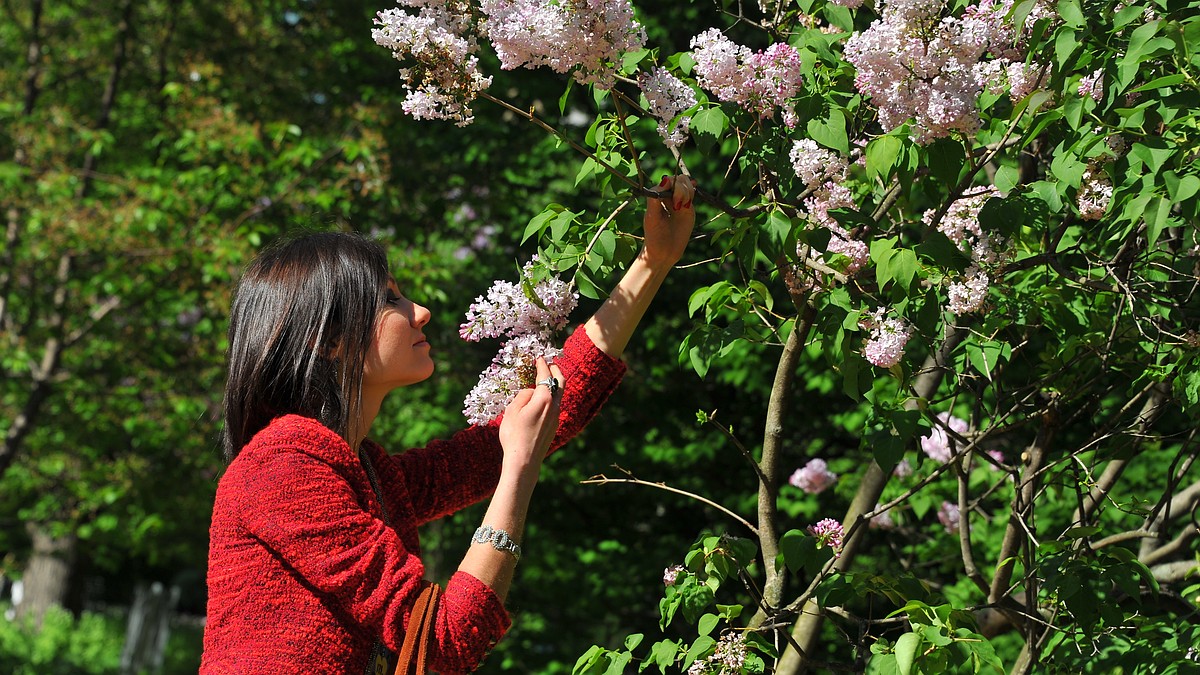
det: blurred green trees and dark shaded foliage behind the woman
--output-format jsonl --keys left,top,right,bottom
{"left": 0, "top": 0, "right": 773, "bottom": 673}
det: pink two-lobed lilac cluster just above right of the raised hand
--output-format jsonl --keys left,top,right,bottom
{"left": 691, "top": 28, "right": 804, "bottom": 127}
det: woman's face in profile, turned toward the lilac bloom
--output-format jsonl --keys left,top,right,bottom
{"left": 362, "top": 280, "right": 433, "bottom": 395}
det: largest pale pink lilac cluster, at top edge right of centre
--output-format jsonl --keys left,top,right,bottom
{"left": 845, "top": 0, "right": 1036, "bottom": 143}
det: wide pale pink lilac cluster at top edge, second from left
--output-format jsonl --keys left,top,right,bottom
{"left": 480, "top": 0, "right": 646, "bottom": 89}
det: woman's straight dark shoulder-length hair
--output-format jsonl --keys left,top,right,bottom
{"left": 222, "top": 232, "right": 389, "bottom": 461}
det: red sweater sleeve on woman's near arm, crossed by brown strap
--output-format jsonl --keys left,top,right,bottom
{"left": 236, "top": 437, "right": 511, "bottom": 673}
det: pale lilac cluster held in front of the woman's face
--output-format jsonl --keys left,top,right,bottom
{"left": 458, "top": 257, "right": 578, "bottom": 424}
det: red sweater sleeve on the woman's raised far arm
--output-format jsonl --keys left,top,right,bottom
{"left": 379, "top": 325, "right": 625, "bottom": 524}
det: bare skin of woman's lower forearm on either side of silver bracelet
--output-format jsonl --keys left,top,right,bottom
{"left": 458, "top": 471, "right": 538, "bottom": 602}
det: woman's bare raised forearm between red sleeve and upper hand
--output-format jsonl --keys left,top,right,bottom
{"left": 584, "top": 249, "right": 671, "bottom": 359}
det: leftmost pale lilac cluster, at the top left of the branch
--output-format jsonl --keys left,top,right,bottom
{"left": 371, "top": 0, "right": 492, "bottom": 126}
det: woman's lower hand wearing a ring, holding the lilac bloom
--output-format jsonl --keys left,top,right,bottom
{"left": 500, "top": 357, "right": 563, "bottom": 472}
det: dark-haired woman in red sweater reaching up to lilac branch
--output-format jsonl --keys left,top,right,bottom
{"left": 200, "top": 177, "right": 695, "bottom": 674}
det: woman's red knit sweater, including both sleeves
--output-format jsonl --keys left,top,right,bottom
{"left": 200, "top": 329, "right": 624, "bottom": 675}
